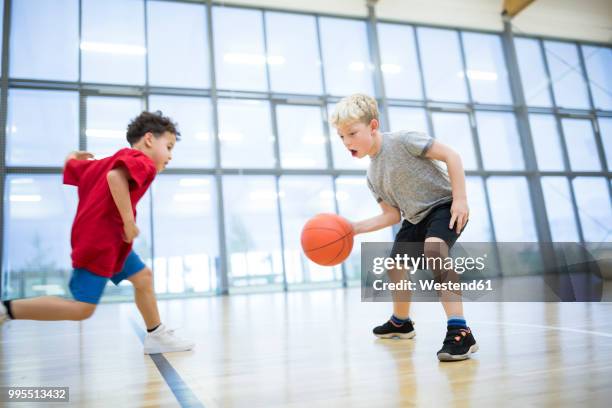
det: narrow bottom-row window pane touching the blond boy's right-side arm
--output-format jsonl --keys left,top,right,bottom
{"left": 459, "top": 177, "right": 493, "bottom": 242}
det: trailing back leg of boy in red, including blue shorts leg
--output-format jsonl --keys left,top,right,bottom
{"left": 0, "top": 269, "right": 108, "bottom": 321}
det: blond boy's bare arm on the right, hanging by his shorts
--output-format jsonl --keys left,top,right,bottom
{"left": 425, "top": 140, "right": 470, "bottom": 234}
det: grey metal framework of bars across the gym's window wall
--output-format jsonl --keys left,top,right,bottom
{"left": 0, "top": 0, "right": 612, "bottom": 297}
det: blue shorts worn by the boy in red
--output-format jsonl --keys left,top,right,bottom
{"left": 69, "top": 251, "right": 146, "bottom": 305}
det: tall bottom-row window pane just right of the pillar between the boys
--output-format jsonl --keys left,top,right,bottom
{"left": 223, "top": 176, "right": 283, "bottom": 288}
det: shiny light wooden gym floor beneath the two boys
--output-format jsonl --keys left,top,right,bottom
{"left": 0, "top": 289, "right": 612, "bottom": 408}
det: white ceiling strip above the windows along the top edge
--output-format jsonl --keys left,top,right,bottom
{"left": 215, "top": 0, "right": 612, "bottom": 43}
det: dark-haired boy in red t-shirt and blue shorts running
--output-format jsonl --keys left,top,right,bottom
{"left": 0, "top": 112, "right": 194, "bottom": 354}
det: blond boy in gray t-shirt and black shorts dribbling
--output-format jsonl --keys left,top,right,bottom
{"left": 330, "top": 94, "right": 478, "bottom": 361}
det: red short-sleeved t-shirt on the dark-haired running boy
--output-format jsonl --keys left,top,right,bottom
{"left": 64, "top": 148, "right": 157, "bottom": 278}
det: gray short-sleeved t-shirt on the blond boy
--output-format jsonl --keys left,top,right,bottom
{"left": 367, "top": 131, "right": 453, "bottom": 224}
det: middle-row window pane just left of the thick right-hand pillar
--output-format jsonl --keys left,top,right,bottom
{"left": 476, "top": 112, "right": 525, "bottom": 170}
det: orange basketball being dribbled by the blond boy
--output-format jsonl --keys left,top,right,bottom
{"left": 302, "top": 214, "right": 353, "bottom": 266}
